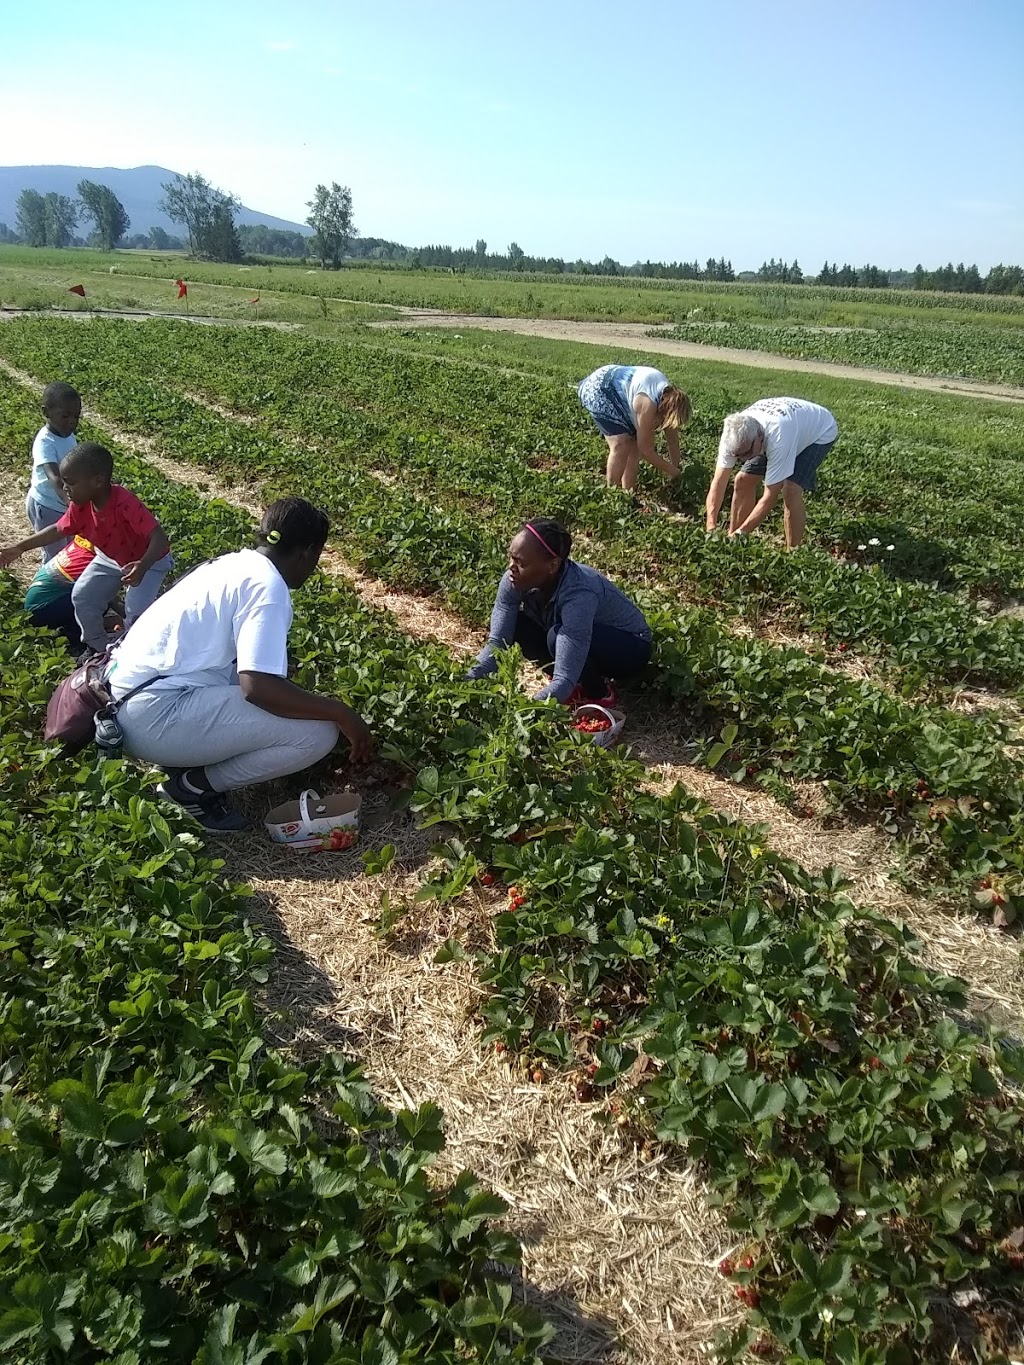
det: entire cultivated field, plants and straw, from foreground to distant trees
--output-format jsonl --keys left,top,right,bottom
{"left": 0, "top": 248, "right": 1024, "bottom": 1365}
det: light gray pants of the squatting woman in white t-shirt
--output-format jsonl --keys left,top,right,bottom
{"left": 117, "top": 684, "right": 337, "bottom": 792}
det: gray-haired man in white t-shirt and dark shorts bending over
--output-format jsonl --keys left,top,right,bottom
{"left": 705, "top": 399, "right": 840, "bottom": 550}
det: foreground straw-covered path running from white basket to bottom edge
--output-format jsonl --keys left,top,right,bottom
{"left": 217, "top": 792, "right": 736, "bottom": 1365}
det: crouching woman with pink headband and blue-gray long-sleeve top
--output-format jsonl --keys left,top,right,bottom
{"left": 468, "top": 517, "right": 651, "bottom": 706}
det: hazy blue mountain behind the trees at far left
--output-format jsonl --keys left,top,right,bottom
{"left": 0, "top": 167, "right": 310, "bottom": 236}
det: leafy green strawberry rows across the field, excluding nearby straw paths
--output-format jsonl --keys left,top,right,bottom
{"left": 0, "top": 318, "right": 1024, "bottom": 1365}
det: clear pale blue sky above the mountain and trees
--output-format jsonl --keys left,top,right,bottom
{"left": 0, "top": 0, "right": 1024, "bottom": 272}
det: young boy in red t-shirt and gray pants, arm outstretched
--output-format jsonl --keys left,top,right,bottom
{"left": 0, "top": 441, "right": 171, "bottom": 652}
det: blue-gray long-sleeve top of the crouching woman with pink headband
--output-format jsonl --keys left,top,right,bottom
{"left": 470, "top": 560, "right": 651, "bottom": 702}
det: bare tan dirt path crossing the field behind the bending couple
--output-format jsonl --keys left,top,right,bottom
{"left": 369, "top": 308, "right": 1024, "bottom": 403}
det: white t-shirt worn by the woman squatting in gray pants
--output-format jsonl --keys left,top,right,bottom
{"left": 108, "top": 550, "right": 292, "bottom": 698}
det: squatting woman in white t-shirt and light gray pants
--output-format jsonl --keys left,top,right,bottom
{"left": 106, "top": 498, "right": 373, "bottom": 833}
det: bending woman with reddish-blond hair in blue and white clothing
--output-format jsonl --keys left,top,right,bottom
{"left": 578, "top": 364, "right": 689, "bottom": 491}
